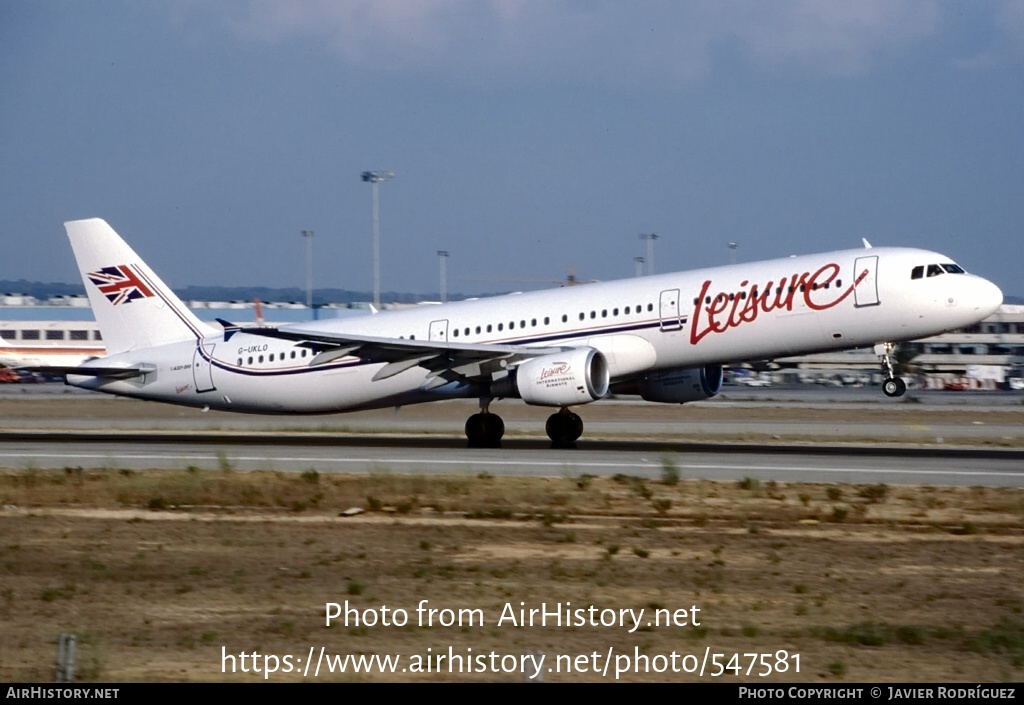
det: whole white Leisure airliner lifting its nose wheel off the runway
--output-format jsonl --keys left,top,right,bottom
{"left": 37, "top": 218, "right": 1002, "bottom": 448}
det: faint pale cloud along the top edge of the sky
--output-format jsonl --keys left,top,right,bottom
{"left": 221, "top": 0, "right": 958, "bottom": 83}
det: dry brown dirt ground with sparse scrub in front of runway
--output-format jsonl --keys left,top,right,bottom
{"left": 0, "top": 460, "right": 1024, "bottom": 682}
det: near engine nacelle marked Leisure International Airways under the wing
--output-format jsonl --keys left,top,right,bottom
{"left": 515, "top": 347, "right": 609, "bottom": 407}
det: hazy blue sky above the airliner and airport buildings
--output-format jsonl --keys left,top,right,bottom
{"left": 0, "top": 0, "right": 1024, "bottom": 295}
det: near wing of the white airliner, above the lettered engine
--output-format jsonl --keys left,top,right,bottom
{"left": 226, "top": 320, "right": 571, "bottom": 381}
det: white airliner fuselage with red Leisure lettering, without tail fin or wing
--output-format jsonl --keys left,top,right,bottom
{"left": 68, "top": 248, "right": 1002, "bottom": 413}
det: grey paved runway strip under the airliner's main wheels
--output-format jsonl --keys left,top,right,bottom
{"left": 0, "top": 433, "right": 1024, "bottom": 487}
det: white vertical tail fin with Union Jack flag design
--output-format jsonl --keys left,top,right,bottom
{"left": 65, "top": 218, "right": 216, "bottom": 355}
